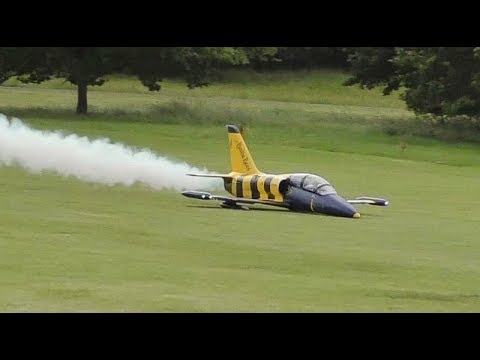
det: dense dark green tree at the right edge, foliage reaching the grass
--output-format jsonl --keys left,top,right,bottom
{"left": 345, "top": 47, "right": 480, "bottom": 116}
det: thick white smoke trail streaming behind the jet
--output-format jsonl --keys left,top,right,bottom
{"left": 0, "top": 114, "right": 221, "bottom": 190}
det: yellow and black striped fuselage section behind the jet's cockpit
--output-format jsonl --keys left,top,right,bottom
{"left": 224, "top": 172, "right": 288, "bottom": 203}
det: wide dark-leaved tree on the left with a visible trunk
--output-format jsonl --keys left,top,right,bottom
{"left": 0, "top": 47, "right": 276, "bottom": 114}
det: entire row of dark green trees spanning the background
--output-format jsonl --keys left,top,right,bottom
{"left": 0, "top": 47, "right": 480, "bottom": 117}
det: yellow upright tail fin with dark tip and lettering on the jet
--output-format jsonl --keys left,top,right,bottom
{"left": 226, "top": 125, "right": 260, "bottom": 174}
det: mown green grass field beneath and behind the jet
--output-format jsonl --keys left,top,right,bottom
{"left": 0, "top": 71, "right": 480, "bottom": 312}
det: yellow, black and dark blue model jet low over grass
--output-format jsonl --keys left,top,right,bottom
{"left": 182, "top": 125, "right": 388, "bottom": 218}
